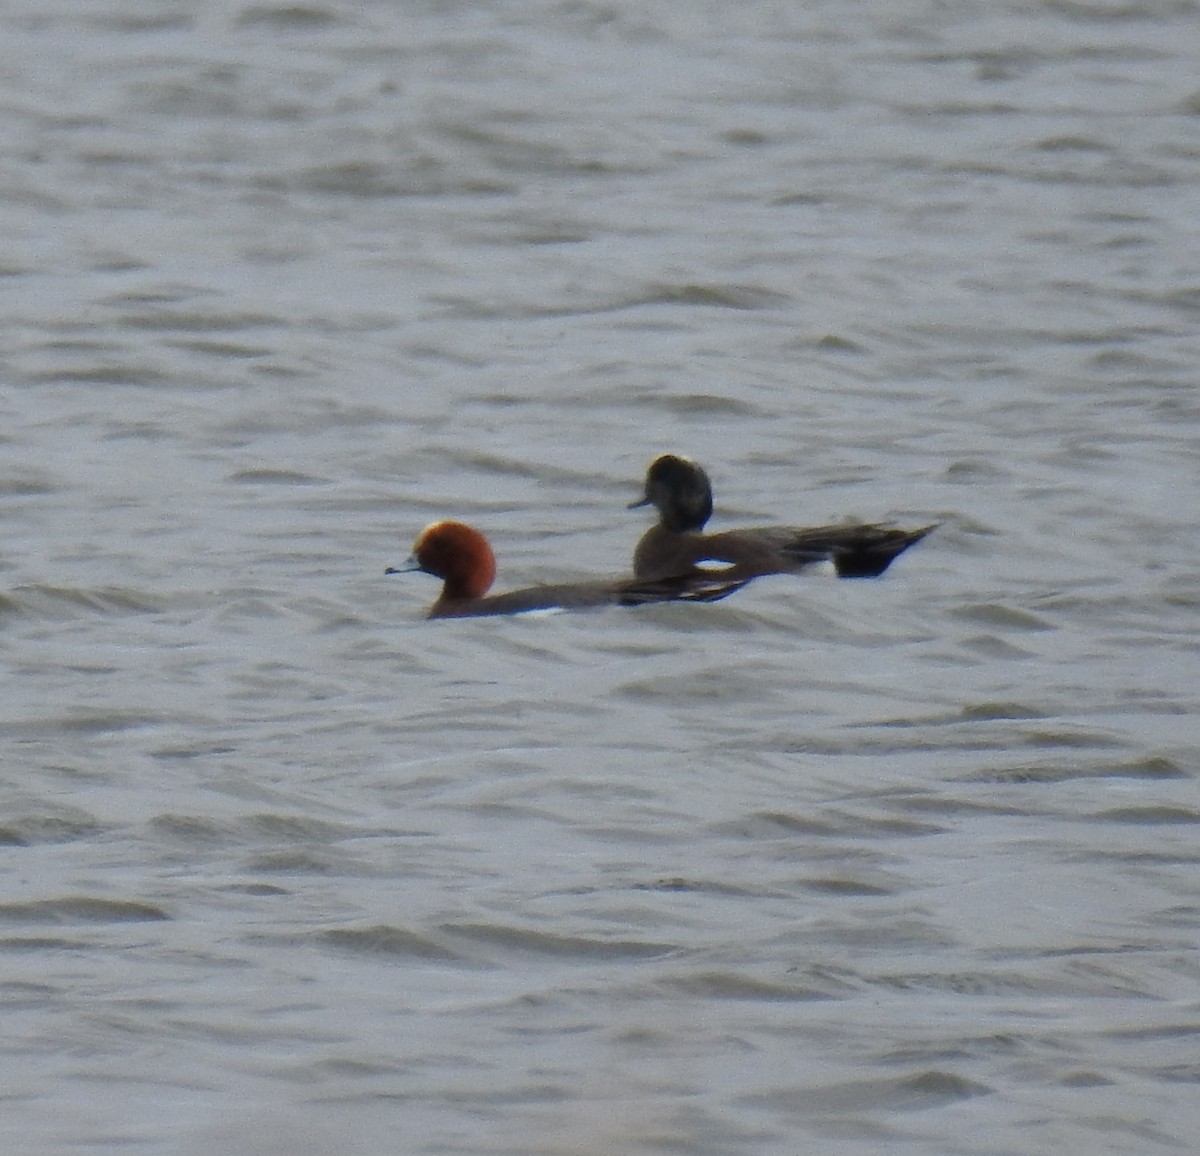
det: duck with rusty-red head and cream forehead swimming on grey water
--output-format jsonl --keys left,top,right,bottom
{"left": 384, "top": 522, "right": 749, "bottom": 618}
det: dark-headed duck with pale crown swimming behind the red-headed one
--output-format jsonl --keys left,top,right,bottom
{"left": 629, "top": 454, "right": 940, "bottom": 581}
